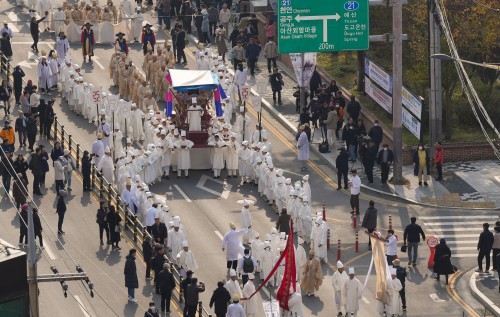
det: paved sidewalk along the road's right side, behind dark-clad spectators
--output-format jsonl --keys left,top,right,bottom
{"left": 228, "top": 48, "right": 500, "bottom": 208}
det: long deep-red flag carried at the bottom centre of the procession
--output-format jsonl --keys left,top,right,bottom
{"left": 276, "top": 221, "right": 297, "bottom": 310}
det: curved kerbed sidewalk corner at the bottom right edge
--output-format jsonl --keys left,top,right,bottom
{"left": 469, "top": 271, "right": 500, "bottom": 317}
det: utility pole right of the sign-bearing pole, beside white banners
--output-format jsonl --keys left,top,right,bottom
{"left": 427, "top": 0, "right": 443, "bottom": 157}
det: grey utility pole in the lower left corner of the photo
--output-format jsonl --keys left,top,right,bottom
{"left": 27, "top": 208, "right": 40, "bottom": 317}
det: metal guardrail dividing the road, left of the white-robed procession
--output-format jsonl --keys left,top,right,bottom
{"left": 52, "top": 116, "right": 212, "bottom": 317}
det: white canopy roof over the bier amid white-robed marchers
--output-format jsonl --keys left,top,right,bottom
{"left": 169, "top": 69, "right": 219, "bottom": 91}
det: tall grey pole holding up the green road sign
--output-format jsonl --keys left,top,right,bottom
{"left": 392, "top": 0, "right": 403, "bottom": 185}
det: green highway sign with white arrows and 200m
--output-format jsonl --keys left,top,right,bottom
{"left": 277, "top": 0, "right": 370, "bottom": 53}
